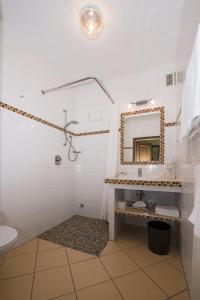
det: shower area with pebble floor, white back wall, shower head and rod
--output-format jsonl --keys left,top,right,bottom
{"left": 36, "top": 77, "right": 114, "bottom": 255}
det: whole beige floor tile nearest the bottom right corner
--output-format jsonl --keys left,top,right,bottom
{"left": 144, "top": 261, "right": 187, "bottom": 297}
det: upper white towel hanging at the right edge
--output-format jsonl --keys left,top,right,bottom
{"left": 180, "top": 25, "right": 200, "bottom": 140}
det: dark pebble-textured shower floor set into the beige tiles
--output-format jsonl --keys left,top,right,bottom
{"left": 39, "top": 215, "right": 109, "bottom": 255}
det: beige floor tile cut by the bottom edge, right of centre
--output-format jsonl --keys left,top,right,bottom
{"left": 114, "top": 271, "right": 167, "bottom": 300}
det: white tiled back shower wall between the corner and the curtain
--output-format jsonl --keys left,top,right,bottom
{"left": 75, "top": 83, "right": 112, "bottom": 217}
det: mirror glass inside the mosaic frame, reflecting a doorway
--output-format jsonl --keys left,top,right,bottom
{"left": 121, "top": 111, "right": 161, "bottom": 164}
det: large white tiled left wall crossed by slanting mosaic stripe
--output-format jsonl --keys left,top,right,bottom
{"left": 0, "top": 24, "right": 75, "bottom": 243}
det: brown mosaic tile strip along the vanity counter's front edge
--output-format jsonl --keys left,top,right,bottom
{"left": 104, "top": 178, "right": 182, "bottom": 187}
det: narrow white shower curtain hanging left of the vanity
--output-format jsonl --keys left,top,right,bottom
{"left": 100, "top": 104, "right": 120, "bottom": 220}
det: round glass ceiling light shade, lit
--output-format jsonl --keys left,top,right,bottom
{"left": 80, "top": 7, "right": 103, "bottom": 39}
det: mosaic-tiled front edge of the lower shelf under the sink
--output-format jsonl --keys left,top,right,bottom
{"left": 115, "top": 208, "right": 181, "bottom": 223}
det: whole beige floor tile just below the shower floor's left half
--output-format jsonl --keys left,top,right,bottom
{"left": 36, "top": 248, "right": 68, "bottom": 272}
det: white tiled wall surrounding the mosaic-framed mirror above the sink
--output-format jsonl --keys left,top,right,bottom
{"left": 108, "top": 64, "right": 180, "bottom": 174}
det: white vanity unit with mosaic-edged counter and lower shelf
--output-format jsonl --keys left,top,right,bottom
{"left": 104, "top": 176, "right": 183, "bottom": 240}
